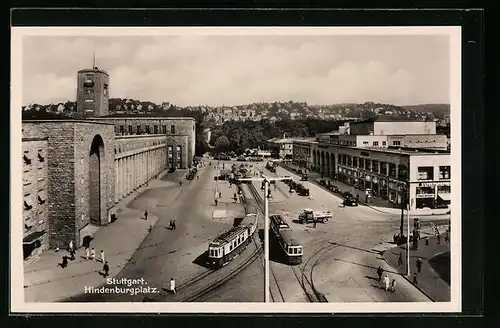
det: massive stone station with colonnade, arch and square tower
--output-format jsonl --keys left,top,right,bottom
{"left": 22, "top": 66, "right": 195, "bottom": 260}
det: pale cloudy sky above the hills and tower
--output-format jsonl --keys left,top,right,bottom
{"left": 22, "top": 35, "right": 450, "bottom": 106}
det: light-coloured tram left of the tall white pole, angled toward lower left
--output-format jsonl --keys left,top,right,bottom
{"left": 208, "top": 213, "right": 258, "bottom": 269}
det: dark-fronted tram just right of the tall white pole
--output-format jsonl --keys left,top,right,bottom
{"left": 269, "top": 214, "right": 303, "bottom": 265}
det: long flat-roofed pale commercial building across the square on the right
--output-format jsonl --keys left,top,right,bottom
{"left": 293, "top": 121, "right": 451, "bottom": 213}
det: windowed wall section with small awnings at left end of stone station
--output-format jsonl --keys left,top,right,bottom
{"left": 22, "top": 138, "right": 49, "bottom": 260}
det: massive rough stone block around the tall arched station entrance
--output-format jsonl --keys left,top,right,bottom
{"left": 22, "top": 120, "right": 114, "bottom": 248}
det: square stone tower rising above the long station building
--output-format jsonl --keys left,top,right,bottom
{"left": 76, "top": 65, "right": 109, "bottom": 117}
